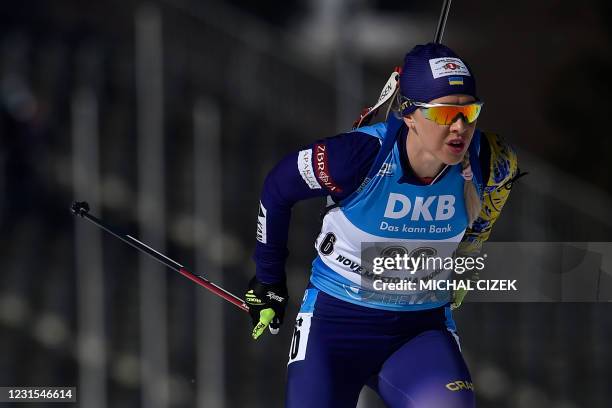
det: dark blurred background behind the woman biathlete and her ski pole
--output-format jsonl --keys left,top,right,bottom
{"left": 0, "top": 0, "right": 612, "bottom": 408}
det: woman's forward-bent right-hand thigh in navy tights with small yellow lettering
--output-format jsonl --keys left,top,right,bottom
{"left": 377, "top": 330, "right": 475, "bottom": 408}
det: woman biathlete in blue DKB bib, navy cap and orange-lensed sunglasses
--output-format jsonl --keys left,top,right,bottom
{"left": 246, "top": 43, "right": 517, "bottom": 408}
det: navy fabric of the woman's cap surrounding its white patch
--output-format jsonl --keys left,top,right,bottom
{"left": 400, "top": 43, "right": 477, "bottom": 115}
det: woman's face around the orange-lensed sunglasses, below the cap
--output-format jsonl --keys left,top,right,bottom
{"left": 404, "top": 95, "right": 476, "bottom": 165}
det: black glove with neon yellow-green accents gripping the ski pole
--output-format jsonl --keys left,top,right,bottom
{"left": 244, "top": 277, "right": 289, "bottom": 340}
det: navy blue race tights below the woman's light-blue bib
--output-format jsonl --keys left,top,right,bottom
{"left": 286, "top": 287, "right": 474, "bottom": 408}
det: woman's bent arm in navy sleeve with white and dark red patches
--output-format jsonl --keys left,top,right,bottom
{"left": 253, "top": 132, "right": 380, "bottom": 284}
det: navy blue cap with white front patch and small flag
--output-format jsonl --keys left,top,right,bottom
{"left": 400, "top": 43, "right": 477, "bottom": 115}
